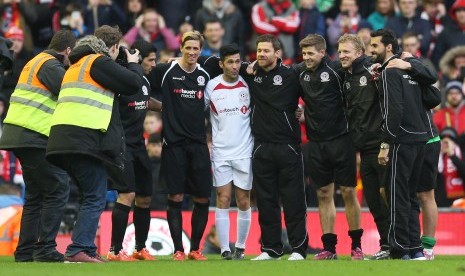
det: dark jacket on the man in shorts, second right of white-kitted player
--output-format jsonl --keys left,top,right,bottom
{"left": 299, "top": 56, "right": 348, "bottom": 141}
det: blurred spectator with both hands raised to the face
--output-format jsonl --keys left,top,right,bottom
{"left": 124, "top": 8, "right": 180, "bottom": 51}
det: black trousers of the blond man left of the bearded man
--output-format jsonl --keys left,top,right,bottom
{"left": 360, "top": 152, "right": 389, "bottom": 250}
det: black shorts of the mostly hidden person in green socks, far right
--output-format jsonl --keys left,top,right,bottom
{"left": 417, "top": 142, "right": 441, "bottom": 192}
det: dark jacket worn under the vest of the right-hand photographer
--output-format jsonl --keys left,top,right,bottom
{"left": 46, "top": 45, "right": 143, "bottom": 169}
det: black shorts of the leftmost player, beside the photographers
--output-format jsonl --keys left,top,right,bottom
{"left": 106, "top": 149, "right": 153, "bottom": 196}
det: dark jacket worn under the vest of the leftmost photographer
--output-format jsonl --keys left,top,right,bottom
{"left": 0, "top": 50, "right": 65, "bottom": 149}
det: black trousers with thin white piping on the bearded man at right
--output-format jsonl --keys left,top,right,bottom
{"left": 386, "top": 144, "right": 425, "bottom": 258}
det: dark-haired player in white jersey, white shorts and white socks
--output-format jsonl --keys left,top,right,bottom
{"left": 205, "top": 44, "right": 253, "bottom": 260}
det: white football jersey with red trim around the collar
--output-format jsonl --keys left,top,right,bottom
{"left": 205, "top": 75, "right": 253, "bottom": 161}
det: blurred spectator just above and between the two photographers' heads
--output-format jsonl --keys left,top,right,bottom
{"left": 53, "top": 2, "right": 87, "bottom": 38}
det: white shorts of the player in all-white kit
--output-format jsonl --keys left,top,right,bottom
{"left": 212, "top": 158, "right": 252, "bottom": 191}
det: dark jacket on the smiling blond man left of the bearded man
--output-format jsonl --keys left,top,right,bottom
{"left": 343, "top": 55, "right": 383, "bottom": 152}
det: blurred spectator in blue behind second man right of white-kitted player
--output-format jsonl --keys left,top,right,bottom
{"left": 294, "top": 0, "right": 326, "bottom": 57}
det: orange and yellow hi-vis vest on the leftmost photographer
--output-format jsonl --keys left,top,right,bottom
{"left": 4, "top": 53, "right": 57, "bottom": 136}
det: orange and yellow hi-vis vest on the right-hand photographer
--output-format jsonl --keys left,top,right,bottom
{"left": 52, "top": 54, "right": 115, "bottom": 132}
